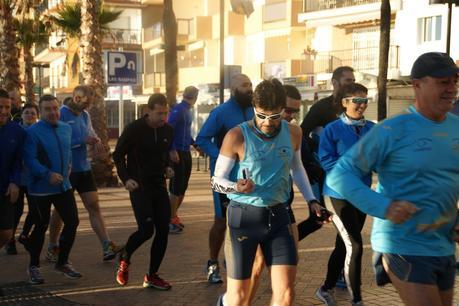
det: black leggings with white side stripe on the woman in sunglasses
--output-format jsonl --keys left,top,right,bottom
{"left": 324, "top": 197, "right": 367, "bottom": 302}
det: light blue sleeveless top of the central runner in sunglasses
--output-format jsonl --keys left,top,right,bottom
{"left": 228, "top": 120, "right": 293, "bottom": 207}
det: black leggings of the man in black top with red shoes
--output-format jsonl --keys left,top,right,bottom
{"left": 123, "top": 187, "right": 171, "bottom": 275}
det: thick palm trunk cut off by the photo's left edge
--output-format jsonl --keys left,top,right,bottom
{"left": 0, "top": 0, "right": 21, "bottom": 91}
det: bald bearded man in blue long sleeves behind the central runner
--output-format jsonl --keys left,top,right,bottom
{"left": 196, "top": 74, "right": 253, "bottom": 283}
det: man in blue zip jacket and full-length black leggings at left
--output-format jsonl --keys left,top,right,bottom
{"left": 24, "top": 95, "right": 81, "bottom": 284}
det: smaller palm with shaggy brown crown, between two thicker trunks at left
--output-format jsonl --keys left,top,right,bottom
{"left": 14, "top": 18, "right": 49, "bottom": 102}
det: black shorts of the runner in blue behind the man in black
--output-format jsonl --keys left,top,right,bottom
{"left": 169, "top": 151, "right": 192, "bottom": 196}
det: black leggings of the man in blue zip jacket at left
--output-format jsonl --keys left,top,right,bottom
{"left": 28, "top": 189, "right": 79, "bottom": 266}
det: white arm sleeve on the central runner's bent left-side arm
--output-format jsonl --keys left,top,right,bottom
{"left": 210, "top": 154, "right": 237, "bottom": 194}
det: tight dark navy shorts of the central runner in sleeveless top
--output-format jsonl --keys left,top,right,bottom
{"left": 225, "top": 201, "right": 298, "bottom": 280}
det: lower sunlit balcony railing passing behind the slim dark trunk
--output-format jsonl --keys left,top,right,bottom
{"left": 300, "top": 46, "right": 400, "bottom": 74}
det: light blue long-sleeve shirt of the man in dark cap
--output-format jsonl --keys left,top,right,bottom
{"left": 327, "top": 106, "right": 459, "bottom": 256}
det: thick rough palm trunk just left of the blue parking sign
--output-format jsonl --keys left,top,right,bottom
{"left": 81, "top": 0, "right": 118, "bottom": 186}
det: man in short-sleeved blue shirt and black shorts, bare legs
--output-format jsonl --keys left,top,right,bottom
{"left": 46, "top": 85, "right": 120, "bottom": 262}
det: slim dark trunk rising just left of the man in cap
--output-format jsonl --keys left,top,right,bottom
{"left": 378, "top": 0, "right": 391, "bottom": 121}
